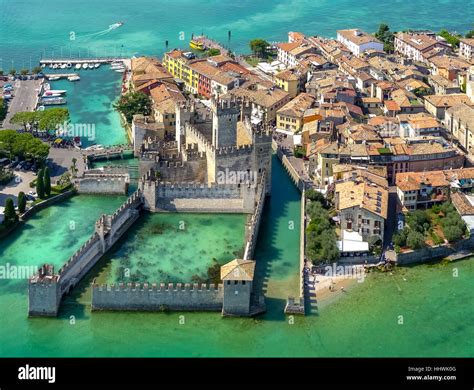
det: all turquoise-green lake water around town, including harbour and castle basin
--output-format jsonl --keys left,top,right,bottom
{"left": 0, "top": 0, "right": 474, "bottom": 356}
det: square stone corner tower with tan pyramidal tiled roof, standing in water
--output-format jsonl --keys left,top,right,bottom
{"left": 221, "top": 259, "right": 255, "bottom": 317}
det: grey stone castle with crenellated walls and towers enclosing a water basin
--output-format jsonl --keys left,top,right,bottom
{"left": 28, "top": 98, "right": 272, "bottom": 316}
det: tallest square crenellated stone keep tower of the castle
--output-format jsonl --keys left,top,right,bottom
{"left": 211, "top": 98, "right": 240, "bottom": 149}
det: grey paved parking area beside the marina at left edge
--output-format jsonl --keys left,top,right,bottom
{"left": 2, "top": 80, "right": 43, "bottom": 130}
